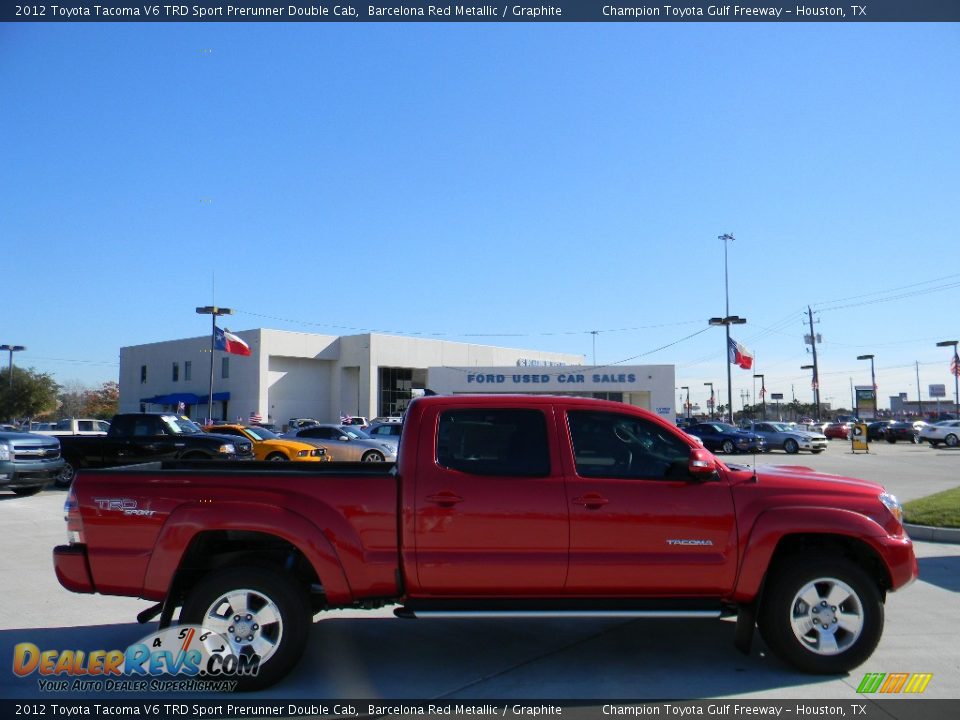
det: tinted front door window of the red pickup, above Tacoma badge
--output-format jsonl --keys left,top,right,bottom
{"left": 567, "top": 410, "right": 690, "bottom": 479}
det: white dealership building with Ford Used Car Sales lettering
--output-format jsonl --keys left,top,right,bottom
{"left": 120, "top": 328, "right": 675, "bottom": 427}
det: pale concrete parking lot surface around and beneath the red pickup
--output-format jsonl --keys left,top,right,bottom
{"left": 0, "top": 441, "right": 960, "bottom": 704}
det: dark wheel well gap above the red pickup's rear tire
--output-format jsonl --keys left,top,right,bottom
{"left": 171, "top": 530, "right": 325, "bottom": 609}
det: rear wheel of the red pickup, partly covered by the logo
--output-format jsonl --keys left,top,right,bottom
{"left": 180, "top": 566, "right": 312, "bottom": 690}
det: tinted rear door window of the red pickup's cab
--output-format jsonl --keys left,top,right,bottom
{"left": 437, "top": 409, "right": 550, "bottom": 477}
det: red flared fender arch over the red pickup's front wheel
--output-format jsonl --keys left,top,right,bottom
{"left": 733, "top": 507, "right": 890, "bottom": 603}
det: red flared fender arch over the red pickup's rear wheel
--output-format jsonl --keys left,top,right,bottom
{"left": 142, "top": 502, "right": 351, "bottom": 604}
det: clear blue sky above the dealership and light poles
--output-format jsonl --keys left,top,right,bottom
{"left": 0, "top": 23, "right": 960, "bottom": 406}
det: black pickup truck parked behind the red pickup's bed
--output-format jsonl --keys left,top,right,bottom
{"left": 56, "top": 413, "right": 253, "bottom": 487}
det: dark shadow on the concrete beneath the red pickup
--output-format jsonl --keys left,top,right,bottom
{"left": 0, "top": 613, "right": 836, "bottom": 710}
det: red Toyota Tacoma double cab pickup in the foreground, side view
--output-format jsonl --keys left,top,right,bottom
{"left": 54, "top": 395, "right": 917, "bottom": 687}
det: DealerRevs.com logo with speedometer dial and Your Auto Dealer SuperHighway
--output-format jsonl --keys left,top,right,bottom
{"left": 13, "top": 625, "right": 260, "bottom": 692}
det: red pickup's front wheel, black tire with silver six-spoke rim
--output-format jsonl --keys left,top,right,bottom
{"left": 757, "top": 554, "right": 883, "bottom": 674}
